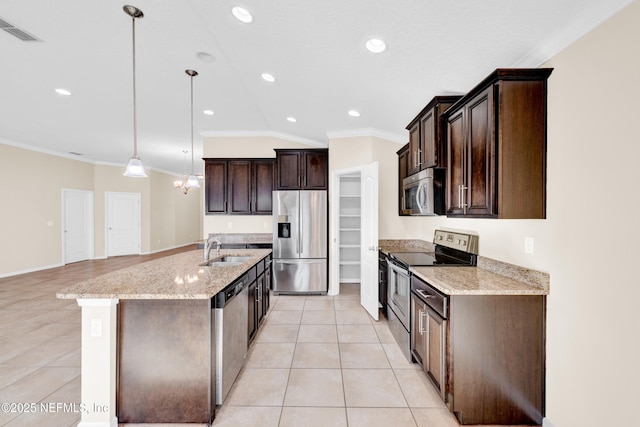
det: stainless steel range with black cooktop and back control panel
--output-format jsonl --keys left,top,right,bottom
{"left": 387, "top": 230, "right": 478, "bottom": 361}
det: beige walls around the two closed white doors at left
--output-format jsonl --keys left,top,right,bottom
{"left": 0, "top": 141, "right": 202, "bottom": 277}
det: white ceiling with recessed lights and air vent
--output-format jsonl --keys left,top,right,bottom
{"left": 0, "top": 0, "right": 630, "bottom": 174}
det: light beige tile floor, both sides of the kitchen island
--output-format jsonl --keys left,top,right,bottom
{"left": 0, "top": 247, "right": 536, "bottom": 427}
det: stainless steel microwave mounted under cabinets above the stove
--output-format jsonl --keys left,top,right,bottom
{"left": 402, "top": 168, "right": 445, "bottom": 215}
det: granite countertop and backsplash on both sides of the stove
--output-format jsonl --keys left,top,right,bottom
{"left": 378, "top": 240, "right": 549, "bottom": 295}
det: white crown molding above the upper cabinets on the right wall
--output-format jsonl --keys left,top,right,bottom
{"left": 512, "top": 0, "right": 633, "bottom": 68}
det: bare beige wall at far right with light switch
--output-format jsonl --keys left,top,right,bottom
{"left": 545, "top": 1, "right": 640, "bottom": 427}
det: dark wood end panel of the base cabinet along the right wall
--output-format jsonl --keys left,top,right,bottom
{"left": 450, "top": 295, "right": 546, "bottom": 425}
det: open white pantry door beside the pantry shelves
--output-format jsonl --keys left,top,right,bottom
{"left": 360, "top": 162, "right": 378, "bottom": 320}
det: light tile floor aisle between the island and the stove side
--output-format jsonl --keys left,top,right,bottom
{"left": 213, "top": 285, "right": 458, "bottom": 427}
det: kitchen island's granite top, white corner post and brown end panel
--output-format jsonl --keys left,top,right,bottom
{"left": 57, "top": 249, "right": 271, "bottom": 427}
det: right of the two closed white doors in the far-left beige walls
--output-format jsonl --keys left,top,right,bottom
{"left": 105, "top": 193, "right": 141, "bottom": 256}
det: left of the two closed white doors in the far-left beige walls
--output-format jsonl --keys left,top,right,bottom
{"left": 62, "top": 189, "right": 93, "bottom": 264}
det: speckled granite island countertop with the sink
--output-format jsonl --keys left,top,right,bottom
{"left": 56, "top": 249, "right": 271, "bottom": 299}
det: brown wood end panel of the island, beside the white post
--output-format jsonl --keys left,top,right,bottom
{"left": 117, "top": 300, "right": 215, "bottom": 423}
